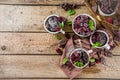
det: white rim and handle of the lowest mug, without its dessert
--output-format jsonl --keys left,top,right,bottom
{"left": 68, "top": 48, "right": 93, "bottom": 69}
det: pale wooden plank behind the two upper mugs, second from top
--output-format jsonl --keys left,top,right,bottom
{"left": 0, "top": 4, "right": 90, "bottom": 32}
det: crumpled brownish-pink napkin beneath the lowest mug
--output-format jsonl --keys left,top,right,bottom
{"left": 60, "top": 35, "right": 90, "bottom": 79}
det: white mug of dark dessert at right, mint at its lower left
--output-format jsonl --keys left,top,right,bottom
{"left": 90, "top": 30, "right": 110, "bottom": 50}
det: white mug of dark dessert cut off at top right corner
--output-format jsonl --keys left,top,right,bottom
{"left": 98, "top": 0, "right": 119, "bottom": 16}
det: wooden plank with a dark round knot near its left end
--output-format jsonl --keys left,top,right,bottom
{"left": 0, "top": 33, "right": 120, "bottom": 55}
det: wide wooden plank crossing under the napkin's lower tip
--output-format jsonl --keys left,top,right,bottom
{"left": 0, "top": 55, "right": 120, "bottom": 79}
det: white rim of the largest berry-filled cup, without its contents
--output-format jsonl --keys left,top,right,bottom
{"left": 72, "top": 14, "right": 96, "bottom": 37}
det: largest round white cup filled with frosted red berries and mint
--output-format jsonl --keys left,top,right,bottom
{"left": 72, "top": 14, "right": 96, "bottom": 37}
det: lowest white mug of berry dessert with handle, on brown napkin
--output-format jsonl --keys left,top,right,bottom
{"left": 68, "top": 48, "right": 93, "bottom": 69}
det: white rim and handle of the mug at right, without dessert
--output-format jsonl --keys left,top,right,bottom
{"left": 90, "top": 30, "right": 110, "bottom": 50}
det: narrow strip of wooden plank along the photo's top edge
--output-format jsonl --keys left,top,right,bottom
{"left": 0, "top": 0, "right": 84, "bottom": 5}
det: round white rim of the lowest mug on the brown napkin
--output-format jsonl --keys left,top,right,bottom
{"left": 69, "top": 48, "right": 90, "bottom": 69}
